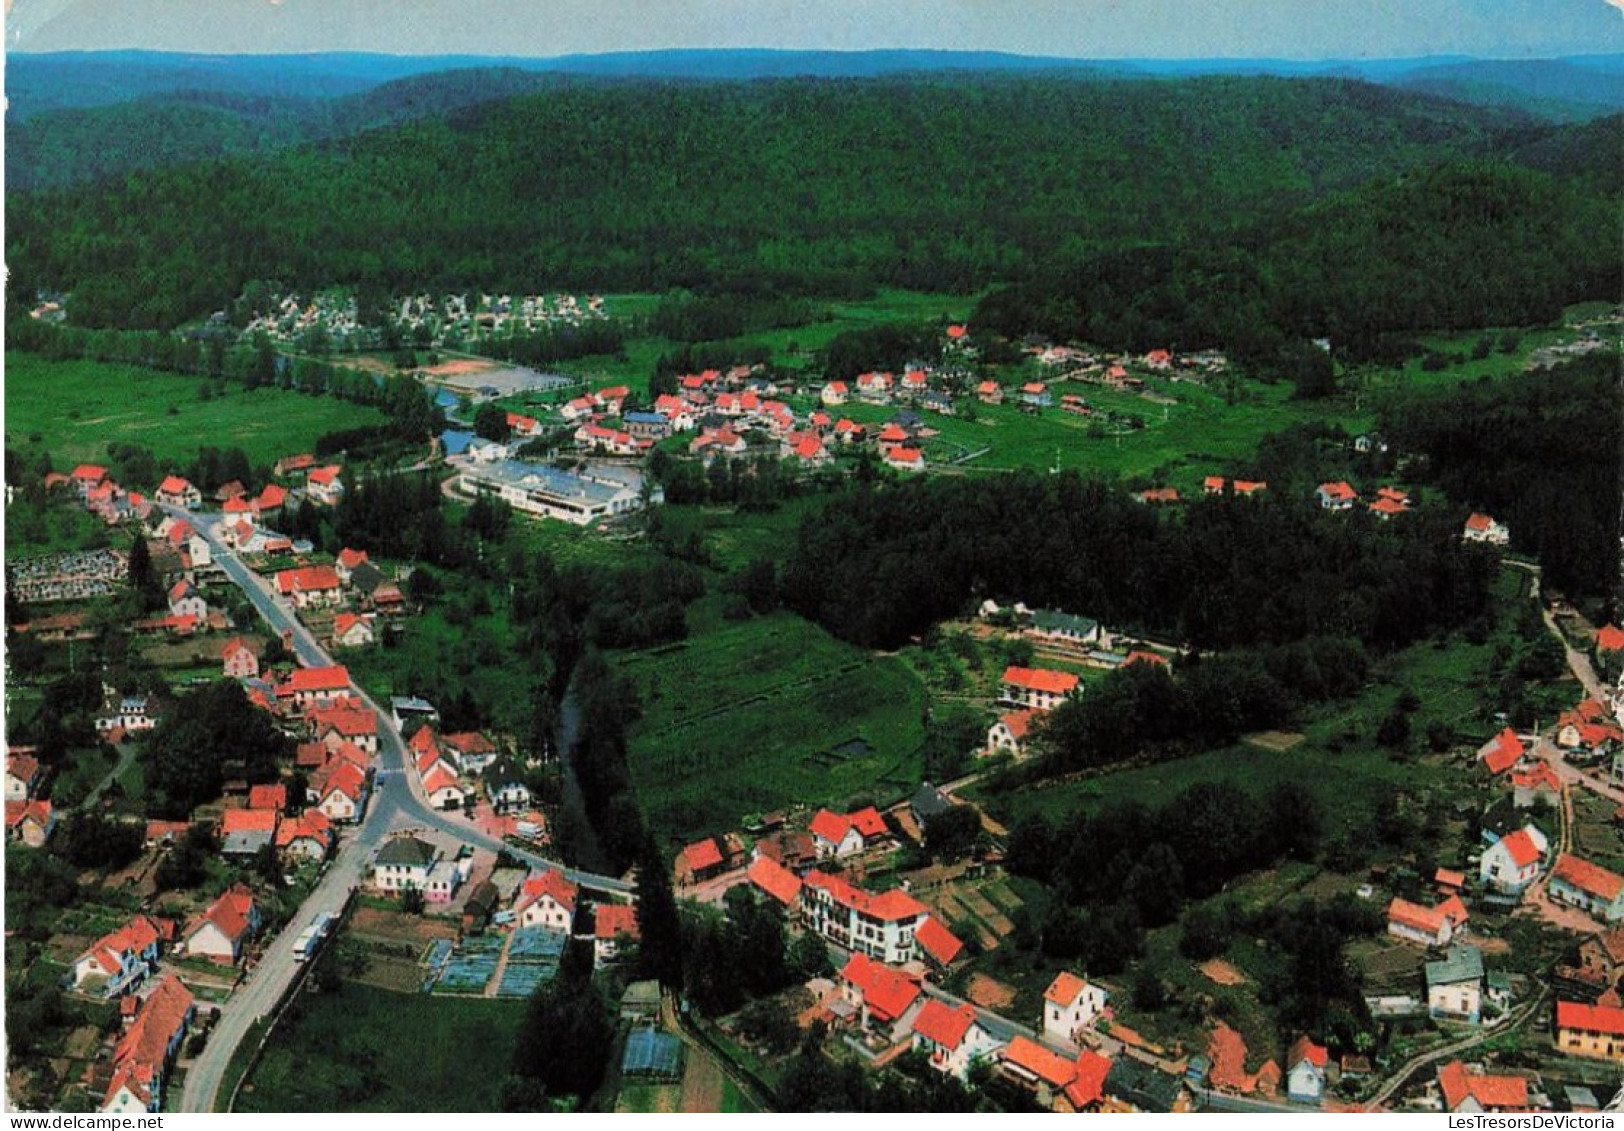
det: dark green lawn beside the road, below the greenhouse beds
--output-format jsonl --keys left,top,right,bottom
{"left": 237, "top": 982, "right": 526, "bottom": 1112}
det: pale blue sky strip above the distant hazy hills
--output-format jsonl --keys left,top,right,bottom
{"left": 6, "top": 0, "right": 1624, "bottom": 59}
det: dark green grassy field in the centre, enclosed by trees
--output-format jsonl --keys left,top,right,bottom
{"left": 617, "top": 613, "right": 924, "bottom": 840}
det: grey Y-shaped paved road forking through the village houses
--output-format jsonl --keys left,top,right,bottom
{"left": 166, "top": 507, "right": 632, "bottom": 1112}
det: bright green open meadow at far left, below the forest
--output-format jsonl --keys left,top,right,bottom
{"left": 5, "top": 351, "right": 383, "bottom": 468}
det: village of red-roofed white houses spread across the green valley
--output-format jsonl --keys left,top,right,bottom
{"left": 6, "top": 351, "right": 1624, "bottom": 1113}
